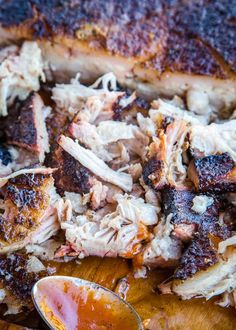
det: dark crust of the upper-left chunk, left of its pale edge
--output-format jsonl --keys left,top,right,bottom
{"left": 5, "top": 93, "right": 42, "bottom": 152}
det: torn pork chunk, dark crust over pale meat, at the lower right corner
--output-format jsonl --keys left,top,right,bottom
{"left": 172, "top": 238, "right": 236, "bottom": 299}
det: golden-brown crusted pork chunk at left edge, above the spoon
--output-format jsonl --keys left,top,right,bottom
{"left": 0, "top": 168, "right": 59, "bottom": 254}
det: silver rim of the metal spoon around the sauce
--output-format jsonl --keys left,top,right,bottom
{"left": 32, "top": 276, "right": 144, "bottom": 330}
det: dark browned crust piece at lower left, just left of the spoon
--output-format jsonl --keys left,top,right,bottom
{"left": 0, "top": 253, "right": 49, "bottom": 305}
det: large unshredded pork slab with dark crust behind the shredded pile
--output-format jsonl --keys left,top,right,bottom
{"left": 0, "top": 0, "right": 236, "bottom": 113}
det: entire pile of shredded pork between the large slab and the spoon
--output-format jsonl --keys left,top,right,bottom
{"left": 0, "top": 42, "right": 236, "bottom": 314}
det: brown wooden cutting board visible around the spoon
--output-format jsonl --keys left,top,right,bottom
{"left": 0, "top": 257, "right": 236, "bottom": 330}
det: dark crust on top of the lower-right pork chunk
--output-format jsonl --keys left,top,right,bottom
{"left": 174, "top": 235, "right": 218, "bottom": 280}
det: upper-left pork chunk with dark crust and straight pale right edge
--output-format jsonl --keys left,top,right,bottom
{"left": 5, "top": 93, "right": 49, "bottom": 162}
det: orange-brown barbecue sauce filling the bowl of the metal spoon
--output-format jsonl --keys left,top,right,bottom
{"left": 35, "top": 280, "right": 140, "bottom": 330}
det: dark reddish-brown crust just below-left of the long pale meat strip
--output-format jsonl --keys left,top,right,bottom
{"left": 48, "top": 147, "right": 92, "bottom": 195}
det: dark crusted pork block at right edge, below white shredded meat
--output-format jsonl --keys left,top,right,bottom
{"left": 188, "top": 153, "right": 236, "bottom": 192}
